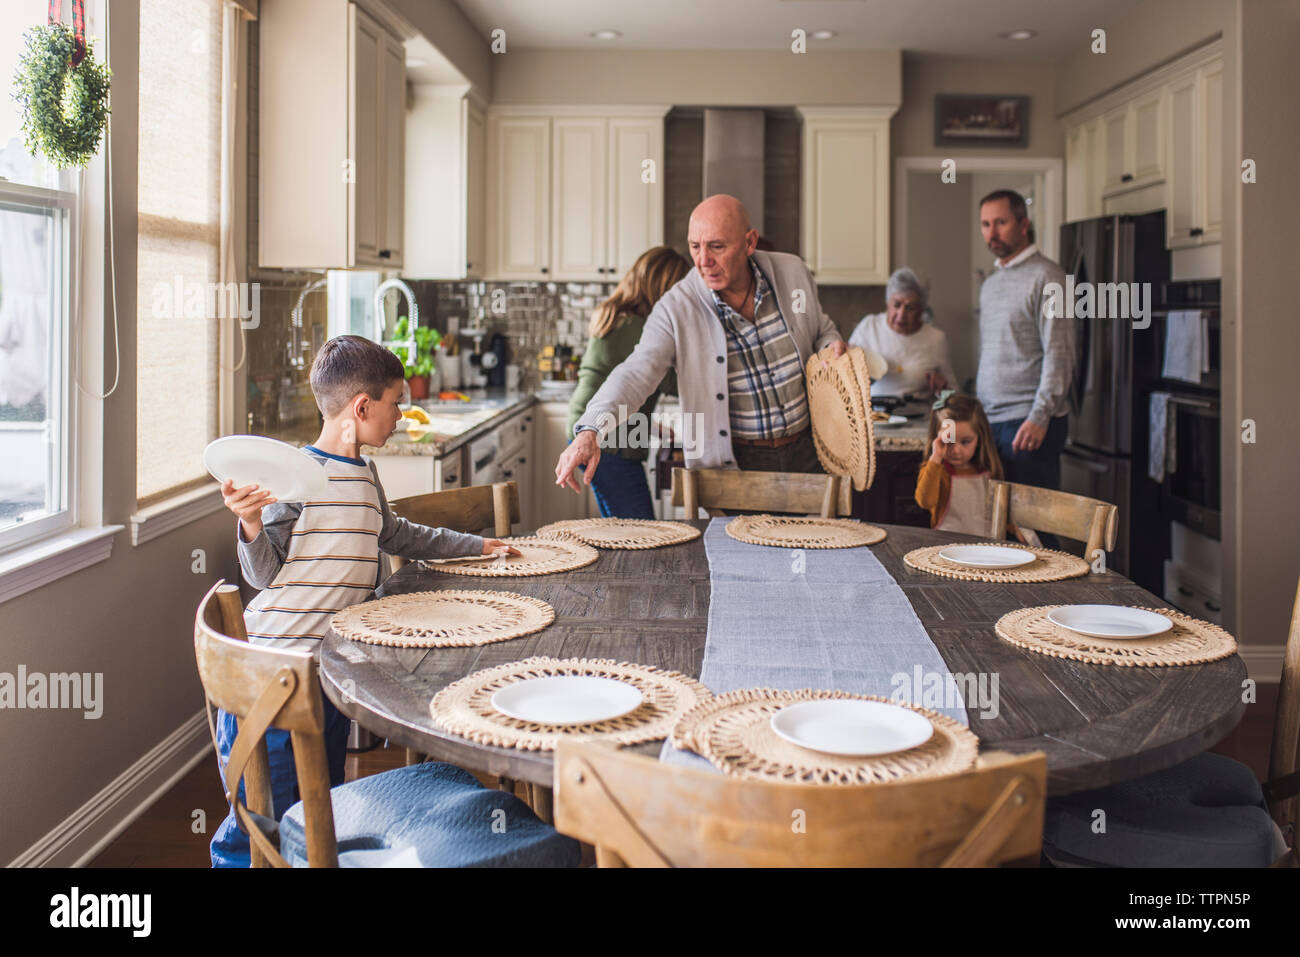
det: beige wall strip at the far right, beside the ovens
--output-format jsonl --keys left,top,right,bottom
{"left": 1222, "top": 0, "right": 1300, "bottom": 644}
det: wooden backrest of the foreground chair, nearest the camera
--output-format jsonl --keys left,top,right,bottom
{"left": 554, "top": 739, "right": 1047, "bottom": 867}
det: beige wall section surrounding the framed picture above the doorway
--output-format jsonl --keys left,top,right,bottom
{"left": 889, "top": 53, "right": 1065, "bottom": 157}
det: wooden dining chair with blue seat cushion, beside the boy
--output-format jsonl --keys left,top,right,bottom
{"left": 194, "top": 581, "right": 580, "bottom": 867}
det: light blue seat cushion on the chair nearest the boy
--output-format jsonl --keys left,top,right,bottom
{"left": 280, "top": 762, "right": 579, "bottom": 867}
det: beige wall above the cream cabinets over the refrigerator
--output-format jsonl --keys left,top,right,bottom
{"left": 1056, "top": 0, "right": 1227, "bottom": 114}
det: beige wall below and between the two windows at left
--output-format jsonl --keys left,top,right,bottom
{"left": 0, "top": 0, "right": 238, "bottom": 862}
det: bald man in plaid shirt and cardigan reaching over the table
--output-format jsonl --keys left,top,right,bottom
{"left": 555, "top": 195, "right": 845, "bottom": 493}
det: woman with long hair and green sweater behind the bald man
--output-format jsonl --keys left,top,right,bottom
{"left": 569, "top": 246, "right": 690, "bottom": 519}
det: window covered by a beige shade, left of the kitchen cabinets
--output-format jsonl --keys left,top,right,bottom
{"left": 135, "top": 0, "right": 224, "bottom": 505}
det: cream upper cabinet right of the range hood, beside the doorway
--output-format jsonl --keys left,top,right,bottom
{"left": 798, "top": 107, "right": 894, "bottom": 286}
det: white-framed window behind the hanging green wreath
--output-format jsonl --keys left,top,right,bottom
{"left": 0, "top": 0, "right": 81, "bottom": 551}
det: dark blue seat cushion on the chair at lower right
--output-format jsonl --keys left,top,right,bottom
{"left": 1043, "top": 753, "right": 1277, "bottom": 867}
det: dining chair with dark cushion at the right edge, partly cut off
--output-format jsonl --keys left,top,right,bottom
{"left": 1044, "top": 586, "right": 1300, "bottom": 867}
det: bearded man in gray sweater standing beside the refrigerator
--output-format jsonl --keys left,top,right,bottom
{"left": 975, "top": 190, "right": 1075, "bottom": 489}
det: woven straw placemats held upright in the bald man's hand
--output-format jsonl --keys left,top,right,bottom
{"left": 805, "top": 350, "right": 875, "bottom": 492}
